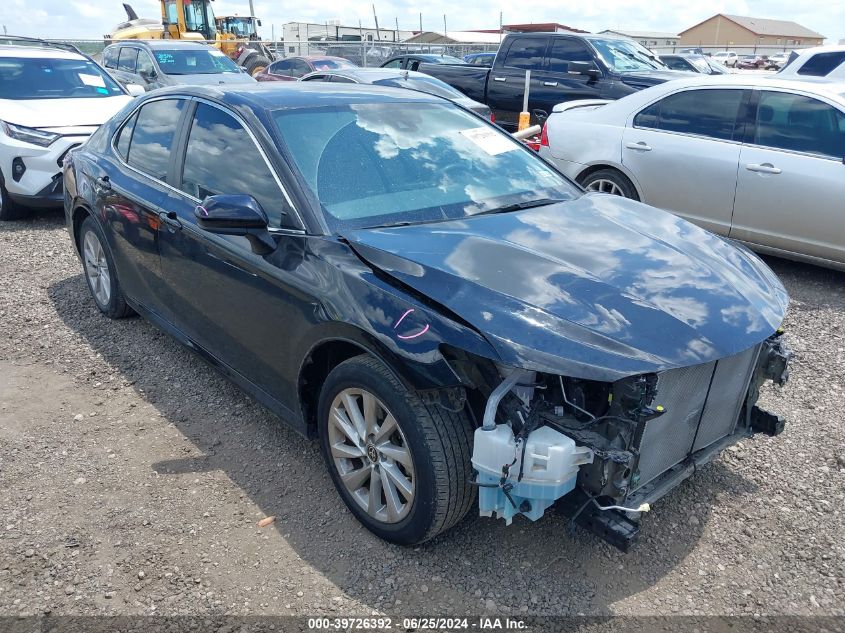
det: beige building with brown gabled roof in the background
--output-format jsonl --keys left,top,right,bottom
{"left": 679, "top": 13, "right": 824, "bottom": 47}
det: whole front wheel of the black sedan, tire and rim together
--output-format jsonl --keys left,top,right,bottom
{"left": 317, "top": 355, "right": 475, "bottom": 545}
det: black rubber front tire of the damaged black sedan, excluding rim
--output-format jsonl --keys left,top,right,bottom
{"left": 318, "top": 355, "right": 475, "bottom": 545}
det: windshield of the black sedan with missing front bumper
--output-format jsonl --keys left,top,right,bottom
{"left": 273, "top": 102, "right": 579, "bottom": 233}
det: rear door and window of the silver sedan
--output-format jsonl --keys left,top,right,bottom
{"left": 622, "top": 88, "right": 750, "bottom": 235}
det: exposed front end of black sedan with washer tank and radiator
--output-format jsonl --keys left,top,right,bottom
{"left": 472, "top": 330, "right": 792, "bottom": 550}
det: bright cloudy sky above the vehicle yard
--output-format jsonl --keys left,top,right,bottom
{"left": 0, "top": 0, "right": 845, "bottom": 44}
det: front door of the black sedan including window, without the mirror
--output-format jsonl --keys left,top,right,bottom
{"left": 160, "top": 101, "right": 303, "bottom": 404}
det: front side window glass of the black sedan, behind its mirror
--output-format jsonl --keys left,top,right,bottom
{"left": 180, "top": 103, "right": 285, "bottom": 226}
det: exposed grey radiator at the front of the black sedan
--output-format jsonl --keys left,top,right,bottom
{"left": 634, "top": 345, "right": 760, "bottom": 489}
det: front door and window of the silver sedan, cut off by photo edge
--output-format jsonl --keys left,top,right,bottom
{"left": 731, "top": 90, "right": 845, "bottom": 263}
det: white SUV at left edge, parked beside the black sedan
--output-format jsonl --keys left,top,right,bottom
{"left": 0, "top": 37, "right": 141, "bottom": 220}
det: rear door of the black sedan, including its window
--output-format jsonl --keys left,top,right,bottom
{"left": 95, "top": 98, "right": 186, "bottom": 316}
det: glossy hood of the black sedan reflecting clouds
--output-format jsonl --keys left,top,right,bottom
{"left": 345, "top": 194, "right": 788, "bottom": 380}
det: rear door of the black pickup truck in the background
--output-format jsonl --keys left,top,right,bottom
{"left": 487, "top": 35, "right": 550, "bottom": 128}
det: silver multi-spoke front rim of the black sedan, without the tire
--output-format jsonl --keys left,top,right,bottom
{"left": 328, "top": 388, "right": 416, "bottom": 523}
